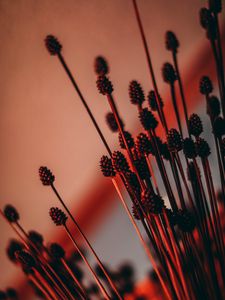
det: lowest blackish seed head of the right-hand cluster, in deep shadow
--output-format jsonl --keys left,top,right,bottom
{"left": 177, "top": 210, "right": 196, "bottom": 233}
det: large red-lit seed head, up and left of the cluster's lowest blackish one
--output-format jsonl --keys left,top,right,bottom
{"left": 141, "top": 189, "right": 164, "bottom": 214}
